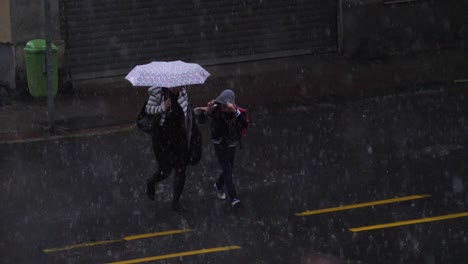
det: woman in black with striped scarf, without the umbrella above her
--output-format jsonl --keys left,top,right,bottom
{"left": 145, "top": 87, "right": 190, "bottom": 211}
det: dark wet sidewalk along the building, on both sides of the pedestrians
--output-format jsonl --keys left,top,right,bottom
{"left": 0, "top": 47, "right": 468, "bottom": 143}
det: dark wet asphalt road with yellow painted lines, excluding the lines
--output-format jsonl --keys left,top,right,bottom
{"left": 0, "top": 87, "right": 468, "bottom": 264}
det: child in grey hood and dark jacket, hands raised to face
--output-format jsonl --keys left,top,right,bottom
{"left": 195, "top": 89, "right": 248, "bottom": 208}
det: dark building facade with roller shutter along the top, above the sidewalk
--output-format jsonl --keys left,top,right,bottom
{"left": 0, "top": 0, "right": 468, "bottom": 99}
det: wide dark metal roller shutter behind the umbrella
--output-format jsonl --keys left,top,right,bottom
{"left": 61, "top": 0, "right": 337, "bottom": 79}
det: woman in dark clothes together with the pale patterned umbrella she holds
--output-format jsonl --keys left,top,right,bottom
{"left": 125, "top": 60, "right": 210, "bottom": 210}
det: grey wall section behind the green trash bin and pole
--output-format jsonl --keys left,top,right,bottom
{"left": 10, "top": 0, "right": 63, "bottom": 93}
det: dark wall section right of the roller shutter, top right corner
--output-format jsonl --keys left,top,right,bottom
{"left": 342, "top": 0, "right": 467, "bottom": 57}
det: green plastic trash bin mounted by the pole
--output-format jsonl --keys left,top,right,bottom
{"left": 24, "top": 39, "right": 58, "bottom": 97}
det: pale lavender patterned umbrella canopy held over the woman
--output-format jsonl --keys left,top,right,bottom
{"left": 125, "top": 60, "right": 210, "bottom": 88}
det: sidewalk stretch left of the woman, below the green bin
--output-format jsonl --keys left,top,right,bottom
{"left": 0, "top": 90, "right": 144, "bottom": 143}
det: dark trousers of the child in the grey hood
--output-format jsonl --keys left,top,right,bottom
{"left": 213, "top": 144, "right": 238, "bottom": 201}
